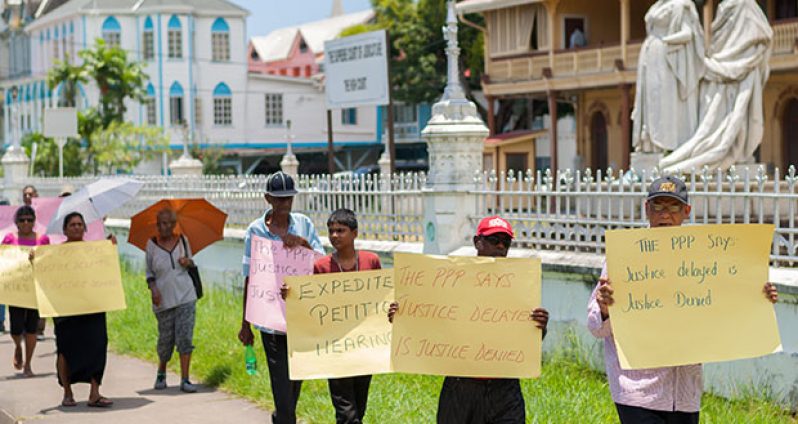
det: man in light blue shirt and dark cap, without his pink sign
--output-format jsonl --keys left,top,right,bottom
{"left": 238, "top": 172, "right": 324, "bottom": 424}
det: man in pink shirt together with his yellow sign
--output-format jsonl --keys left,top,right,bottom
{"left": 587, "top": 176, "right": 778, "bottom": 424}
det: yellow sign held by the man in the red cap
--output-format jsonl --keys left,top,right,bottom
{"left": 391, "top": 253, "right": 542, "bottom": 378}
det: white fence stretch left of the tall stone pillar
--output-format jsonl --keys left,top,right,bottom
{"left": 30, "top": 173, "right": 426, "bottom": 241}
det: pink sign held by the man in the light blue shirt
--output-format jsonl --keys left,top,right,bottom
{"left": 246, "top": 236, "right": 319, "bottom": 332}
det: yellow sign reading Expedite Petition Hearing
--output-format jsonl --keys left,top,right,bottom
{"left": 285, "top": 269, "right": 394, "bottom": 380}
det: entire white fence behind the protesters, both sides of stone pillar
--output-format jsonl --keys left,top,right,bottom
{"left": 25, "top": 167, "right": 798, "bottom": 266}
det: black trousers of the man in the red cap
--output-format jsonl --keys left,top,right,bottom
{"left": 438, "top": 377, "right": 526, "bottom": 424}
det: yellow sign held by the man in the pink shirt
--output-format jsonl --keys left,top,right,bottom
{"left": 606, "top": 224, "right": 781, "bottom": 369}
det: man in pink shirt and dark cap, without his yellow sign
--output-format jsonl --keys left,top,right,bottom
{"left": 587, "top": 176, "right": 778, "bottom": 424}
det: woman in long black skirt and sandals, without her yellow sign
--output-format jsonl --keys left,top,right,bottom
{"left": 54, "top": 212, "right": 113, "bottom": 408}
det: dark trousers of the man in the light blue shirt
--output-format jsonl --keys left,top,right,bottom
{"left": 260, "top": 331, "right": 302, "bottom": 424}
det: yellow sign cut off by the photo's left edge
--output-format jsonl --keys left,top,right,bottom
{"left": 0, "top": 245, "right": 36, "bottom": 309}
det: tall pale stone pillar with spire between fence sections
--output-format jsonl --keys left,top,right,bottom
{"left": 421, "top": 0, "right": 488, "bottom": 254}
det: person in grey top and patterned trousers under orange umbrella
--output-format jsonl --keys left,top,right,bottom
{"left": 146, "top": 208, "right": 197, "bottom": 393}
